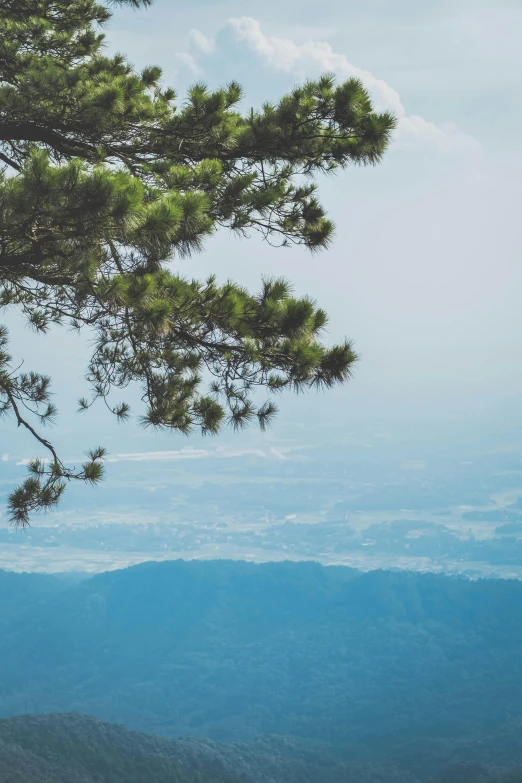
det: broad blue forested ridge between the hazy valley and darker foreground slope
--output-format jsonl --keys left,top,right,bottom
{"left": 0, "top": 561, "right": 522, "bottom": 780}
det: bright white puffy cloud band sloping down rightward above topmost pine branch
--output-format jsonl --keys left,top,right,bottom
{"left": 221, "top": 16, "right": 480, "bottom": 152}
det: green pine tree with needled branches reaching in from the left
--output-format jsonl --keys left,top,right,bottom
{"left": 0, "top": 0, "right": 395, "bottom": 525}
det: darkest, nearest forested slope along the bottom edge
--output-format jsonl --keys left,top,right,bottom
{"left": 0, "top": 715, "right": 522, "bottom": 783}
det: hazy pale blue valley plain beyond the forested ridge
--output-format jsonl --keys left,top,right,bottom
{"left": 0, "top": 414, "right": 522, "bottom": 577}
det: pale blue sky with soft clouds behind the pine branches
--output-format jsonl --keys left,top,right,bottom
{"left": 0, "top": 0, "right": 522, "bottom": 536}
